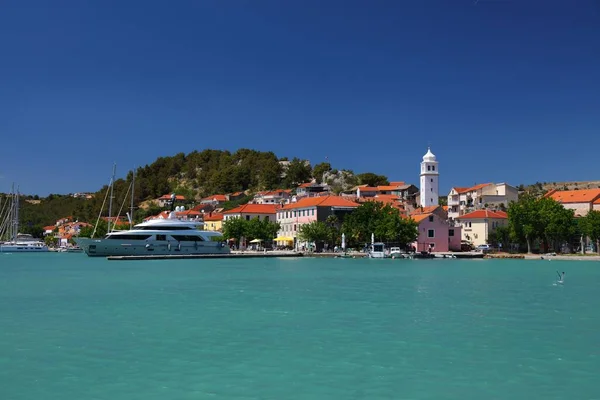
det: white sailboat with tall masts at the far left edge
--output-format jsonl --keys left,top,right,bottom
{"left": 0, "top": 185, "right": 48, "bottom": 253}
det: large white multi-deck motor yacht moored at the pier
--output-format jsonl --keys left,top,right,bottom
{"left": 75, "top": 211, "right": 230, "bottom": 257}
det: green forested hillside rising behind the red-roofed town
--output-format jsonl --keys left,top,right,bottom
{"left": 8, "top": 149, "right": 388, "bottom": 234}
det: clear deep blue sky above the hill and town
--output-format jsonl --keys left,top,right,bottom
{"left": 0, "top": 0, "right": 600, "bottom": 195}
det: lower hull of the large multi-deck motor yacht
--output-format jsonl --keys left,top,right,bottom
{"left": 75, "top": 238, "right": 230, "bottom": 257}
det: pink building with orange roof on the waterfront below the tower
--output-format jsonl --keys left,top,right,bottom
{"left": 410, "top": 206, "right": 461, "bottom": 253}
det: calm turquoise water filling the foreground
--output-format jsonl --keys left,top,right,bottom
{"left": 0, "top": 254, "right": 600, "bottom": 400}
